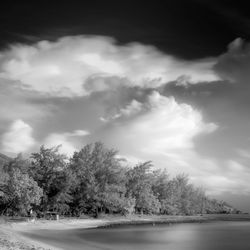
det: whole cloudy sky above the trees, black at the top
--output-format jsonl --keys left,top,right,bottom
{"left": 0, "top": 0, "right": 250, "bottom": 211}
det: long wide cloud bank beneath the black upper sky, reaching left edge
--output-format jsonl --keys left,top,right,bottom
{"left": 0, "top": 36, "right": 218, "bottom": 97}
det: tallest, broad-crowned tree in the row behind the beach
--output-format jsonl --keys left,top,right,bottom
{"left": 69, "top": 142, "right": 125, "bottom": 216}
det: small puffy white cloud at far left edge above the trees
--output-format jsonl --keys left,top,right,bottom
{"left": 2, "top": 120, "right": 35, "bottom": 153}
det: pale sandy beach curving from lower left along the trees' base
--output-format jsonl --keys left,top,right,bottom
{"left": 0, "top": 214, "right": 250, "bottom": 250}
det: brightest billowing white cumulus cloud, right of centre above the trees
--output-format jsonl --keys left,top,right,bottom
{"left": 99, "top": 91, "right": 217, "bottom": 158}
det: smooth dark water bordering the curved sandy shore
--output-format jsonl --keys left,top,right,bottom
{"left": 23, "top": 222, "right": 250, "bottom": 250}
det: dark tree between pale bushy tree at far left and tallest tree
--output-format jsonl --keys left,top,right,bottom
{"left": 29, "top": 146, "right": 72, "bottom": 214}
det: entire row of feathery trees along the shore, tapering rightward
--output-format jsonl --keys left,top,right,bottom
{"left": 0, "top": 142, "right": 238, "bottom": 217}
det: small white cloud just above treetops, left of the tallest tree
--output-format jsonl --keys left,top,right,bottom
{"left": 44, "top": 130, "right": 89, "bottom": 156}
